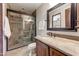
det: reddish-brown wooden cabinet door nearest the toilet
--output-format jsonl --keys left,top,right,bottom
{"left": 36, "top": 40, "right": 48, "bottom": 56}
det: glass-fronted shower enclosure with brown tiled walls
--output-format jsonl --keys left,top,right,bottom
{"left": 7, "top": 10, "right": 35, "bottom": 50}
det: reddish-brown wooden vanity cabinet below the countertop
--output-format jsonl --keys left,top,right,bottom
{"left": 36, "top": 40, "right": 66, "bottom": 56}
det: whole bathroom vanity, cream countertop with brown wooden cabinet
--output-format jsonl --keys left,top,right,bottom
{"left": 35, "top": 36, "right": 79, "bottom": 56}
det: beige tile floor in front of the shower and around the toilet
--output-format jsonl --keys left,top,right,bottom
{"left": 5, "top": 46, "right": 36, "bottom": 56}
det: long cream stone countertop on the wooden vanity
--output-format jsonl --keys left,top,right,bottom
{"left": 35, "top": 36, "right": 79, "bottom": 56}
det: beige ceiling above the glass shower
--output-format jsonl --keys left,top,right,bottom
{"left": 7, "top": 3, "right": 42, "bottom": 14}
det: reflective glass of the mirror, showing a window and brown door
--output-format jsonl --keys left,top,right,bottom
{"left": 49, "top": 4, "right": 71, "bottom": 28}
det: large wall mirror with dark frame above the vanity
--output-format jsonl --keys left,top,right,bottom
{"left": 47, "top": 3, "right": 77, "bottom": 31}
